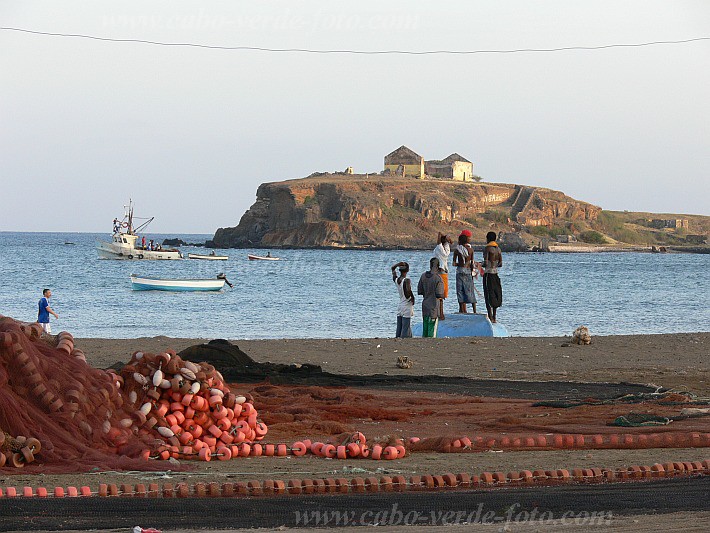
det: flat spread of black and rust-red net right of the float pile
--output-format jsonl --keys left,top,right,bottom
{"left": 175, "top": 340, "right": 710, "bottom": 451}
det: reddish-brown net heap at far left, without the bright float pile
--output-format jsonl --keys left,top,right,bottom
{"left": 0, "top": 317, "right": 170, "bottom": 473}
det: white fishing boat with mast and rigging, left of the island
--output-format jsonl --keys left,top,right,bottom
{"left": 96, "top": 201, "right": 182, "bottom": 260}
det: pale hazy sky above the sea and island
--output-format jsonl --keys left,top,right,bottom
{"left": 0, "top": 0, "right": 710, "bottom": 233}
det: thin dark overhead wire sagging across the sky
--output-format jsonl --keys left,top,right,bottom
{"left": 0, "top": 27, "right": 710, "bottom": 56}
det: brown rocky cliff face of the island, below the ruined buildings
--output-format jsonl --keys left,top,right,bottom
{"left": 213, "top": 174, "right": 600, "bottom": 248}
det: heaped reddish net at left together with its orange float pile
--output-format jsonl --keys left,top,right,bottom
{"left": 0, "top": 317, "right": 267, "bottom": 473}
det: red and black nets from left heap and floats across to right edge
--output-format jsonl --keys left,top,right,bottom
{"left": 0, "top": 317, "right": 710, "bottom": 473}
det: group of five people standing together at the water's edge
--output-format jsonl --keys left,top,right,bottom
{"left": 392, "top": 230, "right": 503, "bottom": 337}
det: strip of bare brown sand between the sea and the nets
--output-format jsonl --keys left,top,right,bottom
{"left": 76, "top": 333, "right": 710, "bottom": 396}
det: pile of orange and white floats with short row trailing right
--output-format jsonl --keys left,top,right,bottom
{"left": 113, "top": 350, "right": 406, "bottom": 461}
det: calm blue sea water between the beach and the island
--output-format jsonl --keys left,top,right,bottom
{"left": 0, "top": 232, "right": 710, "bottom": 339}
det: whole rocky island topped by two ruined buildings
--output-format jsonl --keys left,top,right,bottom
{"left": 206, "top": 146, "right": 710, "bottom": 251}
